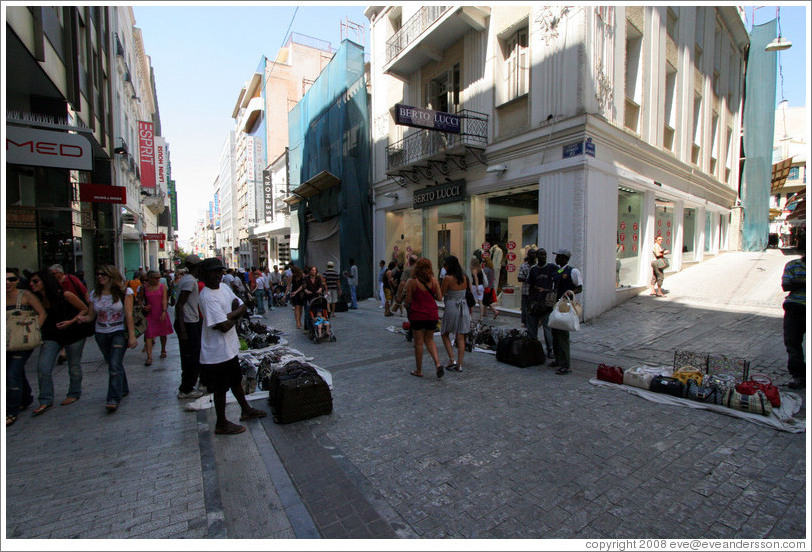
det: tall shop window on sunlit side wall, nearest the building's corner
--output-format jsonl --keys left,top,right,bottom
{"left": 615, "top": 186, "right": 645, "bottom": 288}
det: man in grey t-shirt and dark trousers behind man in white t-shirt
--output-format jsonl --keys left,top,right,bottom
{"left": 174, "top": 255, "right": 205, "bottom": 399}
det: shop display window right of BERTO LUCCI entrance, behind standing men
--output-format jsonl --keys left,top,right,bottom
{"left": 482, "top": 186, "right": 540, "bottom": 298}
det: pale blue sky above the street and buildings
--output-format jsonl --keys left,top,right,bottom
{"left": 133, "top": 2, "right": 809, "bottom": 250}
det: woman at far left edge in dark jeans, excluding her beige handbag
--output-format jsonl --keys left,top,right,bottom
{"left": 6, "top": 270, "right": 48, "bottom": 426}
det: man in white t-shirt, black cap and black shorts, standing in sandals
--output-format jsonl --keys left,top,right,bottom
{"left": 199, "top": 257, "right": 267, "bottom": 435}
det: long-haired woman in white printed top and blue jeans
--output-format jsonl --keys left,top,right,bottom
{"left": 79, "top": 265, "right": 138, "bottom": 413}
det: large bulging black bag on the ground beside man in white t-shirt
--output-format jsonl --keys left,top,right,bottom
{"left": 268, "top": 361, "right": 333, "bottom": 424}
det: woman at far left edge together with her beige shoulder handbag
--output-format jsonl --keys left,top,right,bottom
{"left": 6, "top": 270, "right": 48, "bottom": 426}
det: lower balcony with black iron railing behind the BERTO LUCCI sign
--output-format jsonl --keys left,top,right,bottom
{"left": 386, "top": 109, "right": 488, "bottom": 174}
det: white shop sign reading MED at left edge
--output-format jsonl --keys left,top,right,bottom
{"left": 6, "top": 126, "right": 93, "bottom": 171}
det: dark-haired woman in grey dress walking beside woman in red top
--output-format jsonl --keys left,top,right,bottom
{"left": 440, "top": 255, "right": 471, "bottom": 372}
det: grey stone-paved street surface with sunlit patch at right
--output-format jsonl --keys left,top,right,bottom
{"left": 3, "top": 250, "right": 808, "bottom": 549}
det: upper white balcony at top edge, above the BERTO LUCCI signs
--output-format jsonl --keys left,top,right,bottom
{"left": 383, "top": 6, "right": 490, "bottom": 80}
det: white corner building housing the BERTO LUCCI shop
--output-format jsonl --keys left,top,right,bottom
{"left": 366, "top": 4, "right": 749, "bottom": 318}
